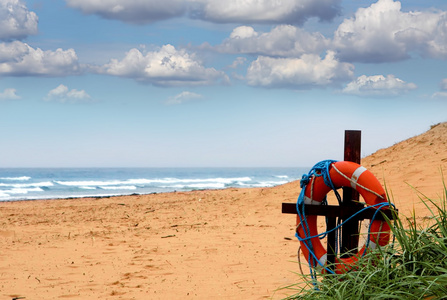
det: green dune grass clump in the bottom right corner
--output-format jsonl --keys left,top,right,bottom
{"left": 287, "top": 184, "right": 447, "bottom": 300}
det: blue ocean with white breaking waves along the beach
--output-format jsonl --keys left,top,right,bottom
{"left": 0, "top": 168, "right": 308, "bottom": 201}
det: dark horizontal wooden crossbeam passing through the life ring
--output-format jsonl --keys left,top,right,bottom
{"left": 282, "top": 203, "right": 397, "bottom": 220}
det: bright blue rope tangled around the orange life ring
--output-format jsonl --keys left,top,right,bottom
{"left": 295, "top": 160, "right": 394, "bottom": 280}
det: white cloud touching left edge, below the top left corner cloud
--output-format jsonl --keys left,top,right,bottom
{"left": 0, "top": 41, "right": 81, "bottom": 76}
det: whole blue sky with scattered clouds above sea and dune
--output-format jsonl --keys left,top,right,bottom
{"left": 0, "top": 0, "right": 447, "bottom": 167}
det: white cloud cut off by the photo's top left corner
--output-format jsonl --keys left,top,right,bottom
{"left": 0, "top": 0, "right": 38, "bottom": 40}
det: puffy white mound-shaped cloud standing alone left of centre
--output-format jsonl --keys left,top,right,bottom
{"left": 97, "top": 45, "right": 228, "bottom": 86}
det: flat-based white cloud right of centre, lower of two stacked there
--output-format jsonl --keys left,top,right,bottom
{"left": 246, "top": 51, "right": 354, "bottom": 89}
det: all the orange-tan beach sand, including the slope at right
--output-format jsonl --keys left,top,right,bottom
{"left": 0, "top": 123, "right": 447, "bottom": 299}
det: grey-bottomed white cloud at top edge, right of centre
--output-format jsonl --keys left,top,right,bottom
{"left": 189, "top": 0, "right": 341, "bottom": 24}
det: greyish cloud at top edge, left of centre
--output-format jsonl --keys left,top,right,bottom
{"left": 66, "top": 0, "right": 186, "bottom": 24}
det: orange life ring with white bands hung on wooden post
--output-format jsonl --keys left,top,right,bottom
{"left": 296, "top": 161, "right": 390, "bottom": 273}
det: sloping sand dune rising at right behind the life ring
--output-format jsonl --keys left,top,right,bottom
{"left": 362, "top": 122, "right": 447, "bottom": 215}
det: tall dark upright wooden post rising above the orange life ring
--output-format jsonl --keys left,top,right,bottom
{"left": 340, "top": 130, "right": 363, "bottom": 257}
